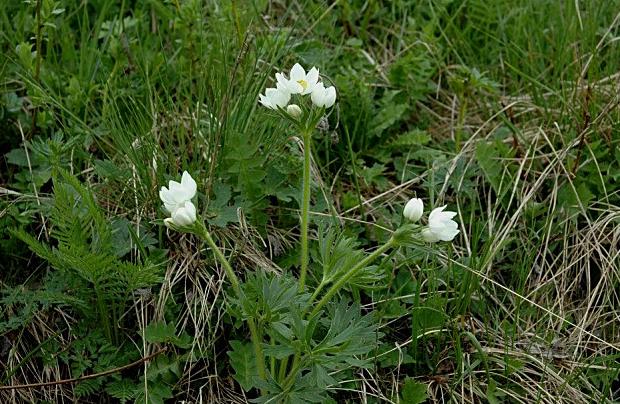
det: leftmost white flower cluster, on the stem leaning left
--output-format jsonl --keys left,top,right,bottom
{"left": 159, "top": 171, "right": 196, "bottom": 227}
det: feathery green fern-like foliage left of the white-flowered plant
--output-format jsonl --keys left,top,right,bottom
{"left": 15, "top": 171, "right": 161, "bottom": 341}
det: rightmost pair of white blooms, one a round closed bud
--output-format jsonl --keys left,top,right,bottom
{"left": 403, "top": 198, "right": 459, "bottom": 243}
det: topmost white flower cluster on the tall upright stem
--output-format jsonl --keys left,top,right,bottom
{"left": 258, "top": 63, "right": 336, "bottom": 113}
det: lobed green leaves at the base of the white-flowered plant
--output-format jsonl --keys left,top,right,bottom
{"left": 228, "top": 272, "right": 381, "bottom": 402}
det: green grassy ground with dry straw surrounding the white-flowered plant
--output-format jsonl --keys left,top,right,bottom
{"left": 0, "top": 0, "right": 620, "bottom": 403}
